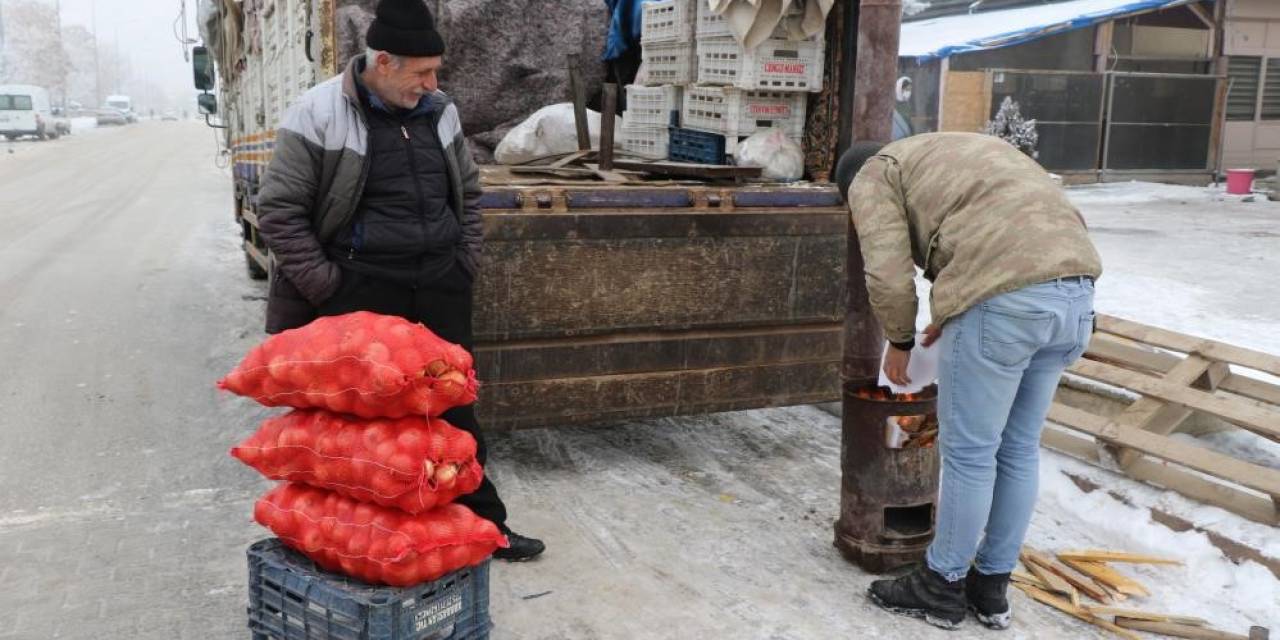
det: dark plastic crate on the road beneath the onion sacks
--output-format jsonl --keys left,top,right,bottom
{"left": 248, "top": 538, "right": 493, "bottom": 640}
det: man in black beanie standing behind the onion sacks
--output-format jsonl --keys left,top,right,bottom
{"left": 259, "top": 0, "right": 544, "bottom": 561}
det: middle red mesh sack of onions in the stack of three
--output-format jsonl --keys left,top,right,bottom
{"left": 232, "top": 411, "right": 484, "bottom": 513}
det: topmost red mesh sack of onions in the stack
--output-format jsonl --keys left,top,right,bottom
{"left": 218, "top": 311, "right": 477, "bottom": 417}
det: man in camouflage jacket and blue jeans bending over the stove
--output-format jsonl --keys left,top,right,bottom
{"left": 836, "top": 133, "right": 1102, "bottom": 628}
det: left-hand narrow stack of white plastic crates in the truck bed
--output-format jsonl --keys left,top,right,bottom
{"left": 621, "top": 0, "right": 704, "bottom": 160}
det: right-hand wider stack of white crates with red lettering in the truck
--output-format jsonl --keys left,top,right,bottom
{"left": 681, "top": 0, "right": 826, "bottom": 155}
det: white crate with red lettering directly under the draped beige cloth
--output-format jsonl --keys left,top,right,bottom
{"left": 698, "top": 38, "right": 826, "bottom": 91}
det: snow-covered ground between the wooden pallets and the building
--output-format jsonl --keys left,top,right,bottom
{"left": 1069, "top": 183, "right": 1280, "bottom": 353}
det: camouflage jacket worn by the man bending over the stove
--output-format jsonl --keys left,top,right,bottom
{"left": 849, "top": 133, "right": 1102, "bottom": 343}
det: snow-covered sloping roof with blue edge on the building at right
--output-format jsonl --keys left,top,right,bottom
{"left": 899, "top": 0, "right": 1197, "bottom": 61}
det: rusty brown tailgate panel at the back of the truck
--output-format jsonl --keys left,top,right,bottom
{"left": 474, "top": 200, "right": 847, "bottom": 429}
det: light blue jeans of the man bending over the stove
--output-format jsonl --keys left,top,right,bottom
{"left": 925, "top": 278, "right": 1093, "bottom": 581}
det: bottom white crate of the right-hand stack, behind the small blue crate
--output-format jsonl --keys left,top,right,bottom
{"left": 681, "top": 86, "right": 809, "bottom": 141}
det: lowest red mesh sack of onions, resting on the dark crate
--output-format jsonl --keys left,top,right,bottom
{"left": 253, "top": 483, "right": 507, "bottom": 586}
